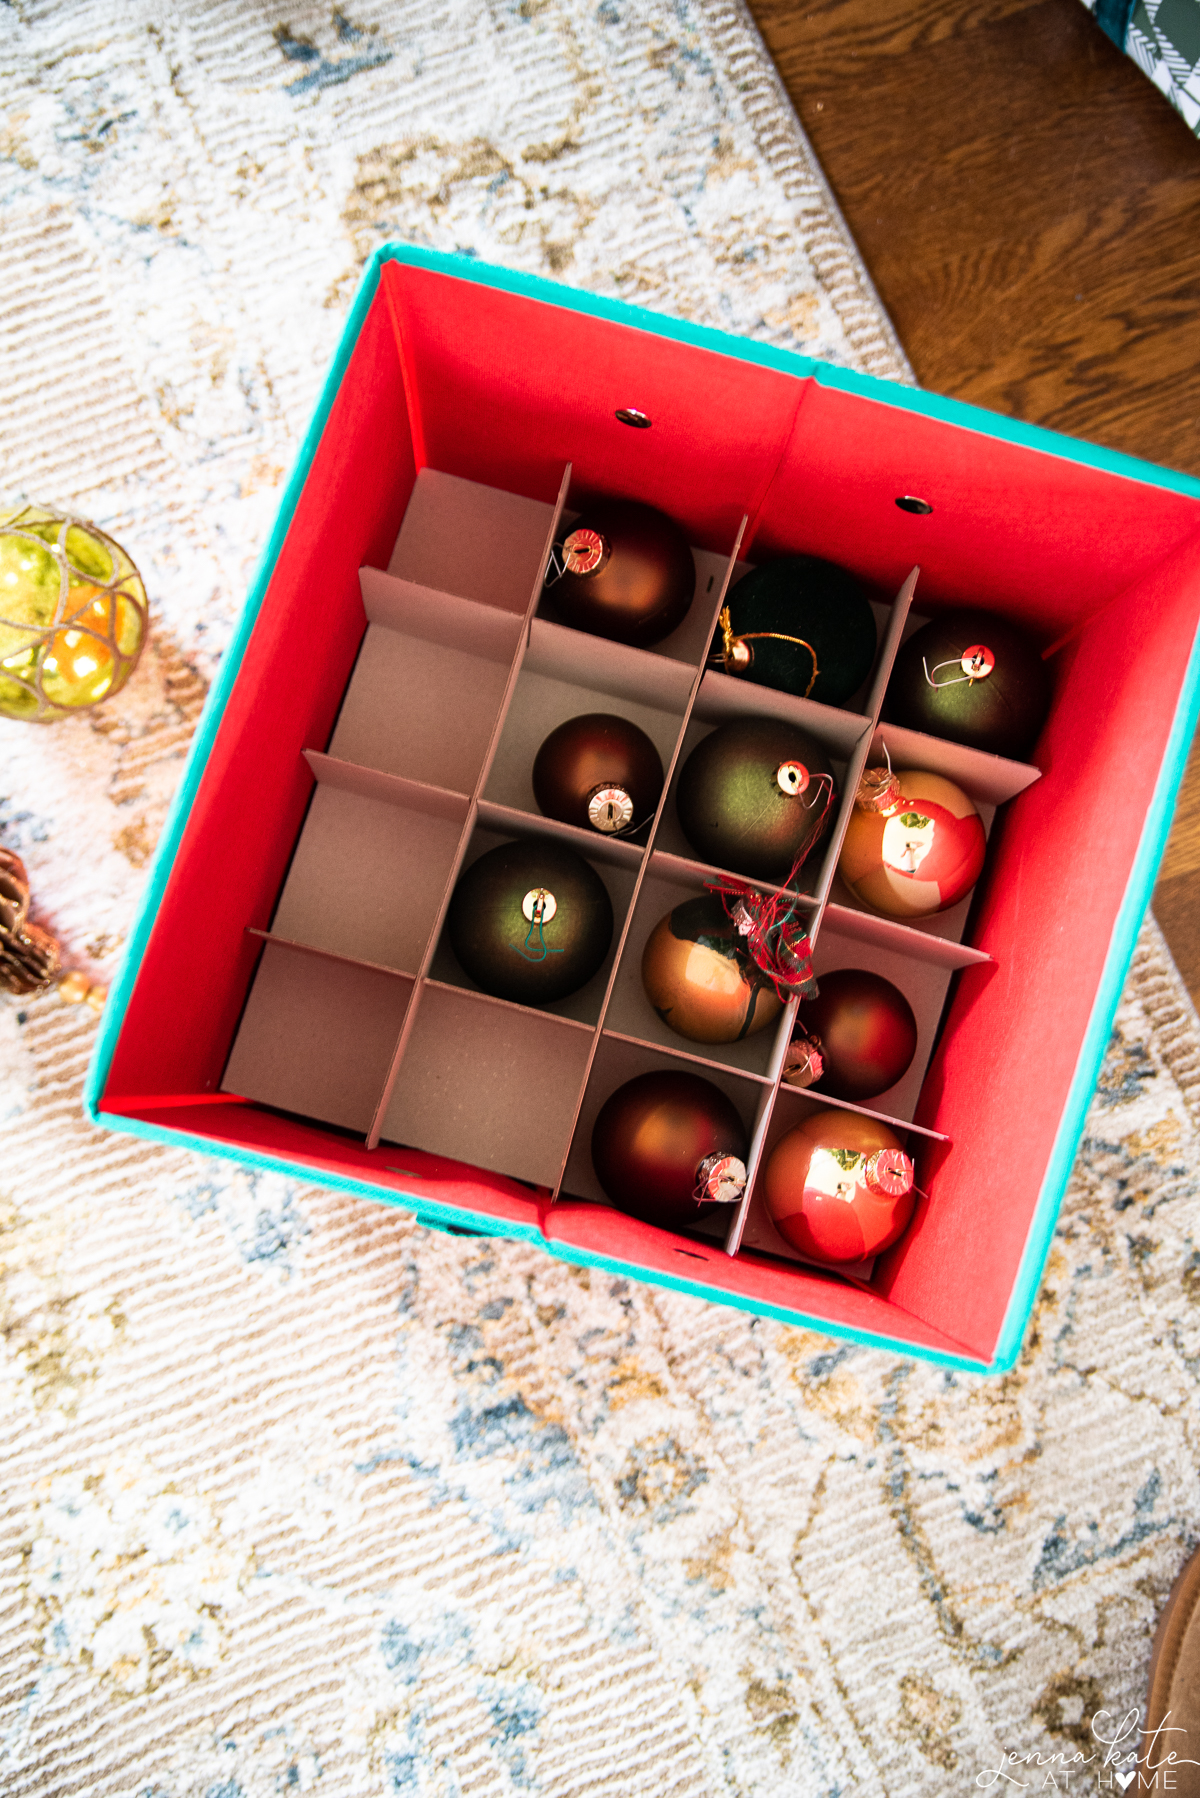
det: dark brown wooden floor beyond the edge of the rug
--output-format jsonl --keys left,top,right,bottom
{"left": 750, "top": 0, "right": 1200, "bottom": 1003}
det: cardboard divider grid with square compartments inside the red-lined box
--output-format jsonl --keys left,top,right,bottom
{"left": 223, "top": 467, "right": 1036, "bottom": 1282}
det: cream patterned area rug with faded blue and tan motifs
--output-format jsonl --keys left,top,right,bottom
{"left": 0, "top": 0, "right": 1200, "bottom": 1798}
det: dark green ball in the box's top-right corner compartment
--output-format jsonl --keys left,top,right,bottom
{"left": 887, "top": 611, "right": 1052, "bottom": 757}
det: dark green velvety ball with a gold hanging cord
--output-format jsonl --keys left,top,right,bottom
{"left": 709, "top": 556, "right": 878, "bottom": 705}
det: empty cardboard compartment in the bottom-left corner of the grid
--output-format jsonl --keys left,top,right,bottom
{"left": 221, "top": 942, "right": 414, "bottom": 1133}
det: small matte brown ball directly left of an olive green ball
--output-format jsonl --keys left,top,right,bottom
{"left": 533, "top": 712, "right": 662, "bottom": 836}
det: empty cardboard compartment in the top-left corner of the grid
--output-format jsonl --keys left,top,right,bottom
{"left": 387, "top": 467, "right": 554, "bottom": 619}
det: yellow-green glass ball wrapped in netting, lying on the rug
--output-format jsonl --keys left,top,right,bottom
{"left": 0, "top": 505, "right": 149, "bottom": 725}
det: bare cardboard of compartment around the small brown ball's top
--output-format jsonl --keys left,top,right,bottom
{"left": 484, "top": 619, "right": 694, "bottom": 825}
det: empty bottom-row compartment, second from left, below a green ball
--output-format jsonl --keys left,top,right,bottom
{"left": 381, "top": 980, "right": 592, "bottom": 1187}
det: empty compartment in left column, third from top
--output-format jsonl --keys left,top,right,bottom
{"left": 272, "top": 750, "right": 468, "bottom": 973}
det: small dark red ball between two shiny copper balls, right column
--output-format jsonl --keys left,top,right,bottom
{"left": 797, "top": 967, "right": 918, "bottom": 1104}
